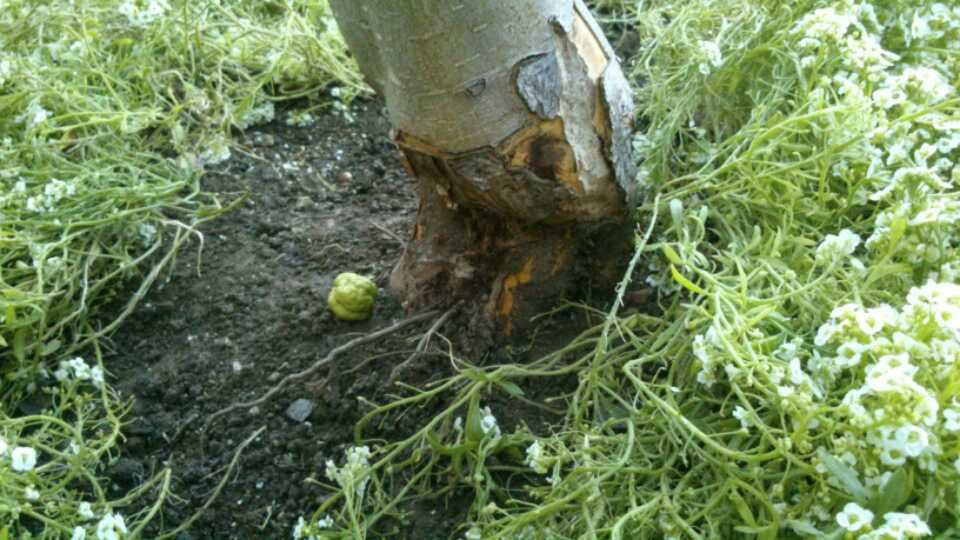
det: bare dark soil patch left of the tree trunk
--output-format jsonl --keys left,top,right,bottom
{"left": 107, "top": 105, "right": 592, "bottom": 539}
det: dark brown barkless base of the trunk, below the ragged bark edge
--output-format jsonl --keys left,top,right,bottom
{"left": 390, "top": 146, "right": 633, "bottom": 336}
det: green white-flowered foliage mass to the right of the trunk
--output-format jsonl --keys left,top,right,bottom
{"left": 311, "top": 0, "right": 960, "bottom": 540}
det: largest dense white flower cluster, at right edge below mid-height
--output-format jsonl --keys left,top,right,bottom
{"left": 813, "top": 282, "right": 960, "bottom": 472}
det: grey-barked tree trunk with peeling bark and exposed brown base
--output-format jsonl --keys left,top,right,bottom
{"left": 331, "top": 0, "right": 635, "bottom": 335}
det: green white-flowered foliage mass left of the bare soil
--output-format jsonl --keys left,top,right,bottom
{"left": 0, "top": 0, "right": 364, "bottom": 538}
